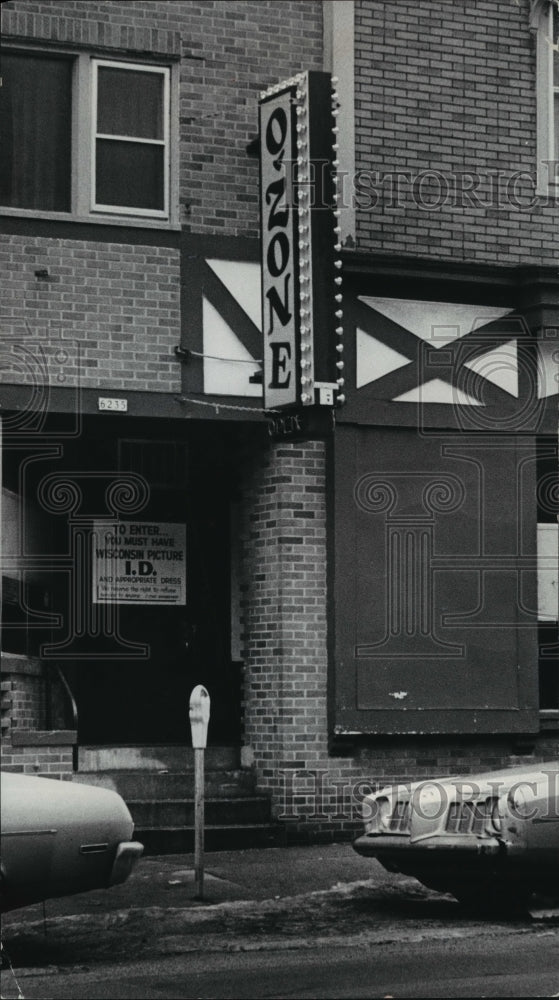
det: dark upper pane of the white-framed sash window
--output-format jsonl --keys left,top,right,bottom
{"left": 97, "top": 66, "right": 163, "bottom": 139}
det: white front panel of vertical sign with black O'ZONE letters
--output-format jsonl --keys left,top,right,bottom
{"left": 260, "top": 77, "right": 299, "bottom": 409}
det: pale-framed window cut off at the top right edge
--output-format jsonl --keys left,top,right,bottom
{"left": 532, "top": 0, "right": 559, "bottom": 197}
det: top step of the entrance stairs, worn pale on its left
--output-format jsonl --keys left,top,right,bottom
{"left": 78, "top": 745, "right": 240, "bottom": 772}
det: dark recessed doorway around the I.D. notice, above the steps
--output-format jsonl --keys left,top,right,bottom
{"left": 2, "top": 416, "right": 240, "bottom": 745}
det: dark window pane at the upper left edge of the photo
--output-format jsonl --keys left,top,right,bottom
{"left": 0, "top": 53, "right": 72, "bottom": 212}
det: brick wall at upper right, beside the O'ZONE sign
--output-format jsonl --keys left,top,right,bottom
{"left": 355, "top": 0, "right": 559, "bottom": 265}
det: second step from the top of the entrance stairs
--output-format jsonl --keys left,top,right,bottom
{"left": 73, "top": 768, "right": 255, "bottom": 802}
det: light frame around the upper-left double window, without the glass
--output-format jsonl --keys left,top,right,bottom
{"left": 0, "top": 42, "right": 180, "bottom": 230}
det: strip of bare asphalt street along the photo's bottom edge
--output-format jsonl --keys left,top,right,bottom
{"left": 2, "top": 927, "right": 559, "bottom": 1000}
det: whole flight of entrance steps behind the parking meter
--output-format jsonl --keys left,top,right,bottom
{"left": 73, "top": 746, "right": 281, "bottom": 854}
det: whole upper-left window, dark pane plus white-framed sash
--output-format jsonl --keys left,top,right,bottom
{"left": 0, "top": 50, "right": 172, "bottom": 221}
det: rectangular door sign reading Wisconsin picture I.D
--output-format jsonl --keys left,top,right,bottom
{"left": 92, "top": 521, "right": 186, "bottom": 604}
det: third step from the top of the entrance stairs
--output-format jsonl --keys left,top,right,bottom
{"left": 130, "top": 795, "right": 270, "bottom": 824}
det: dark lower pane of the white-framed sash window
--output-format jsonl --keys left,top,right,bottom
{"left": 96, "top": 139, "right": 165, "bottom": 211}
